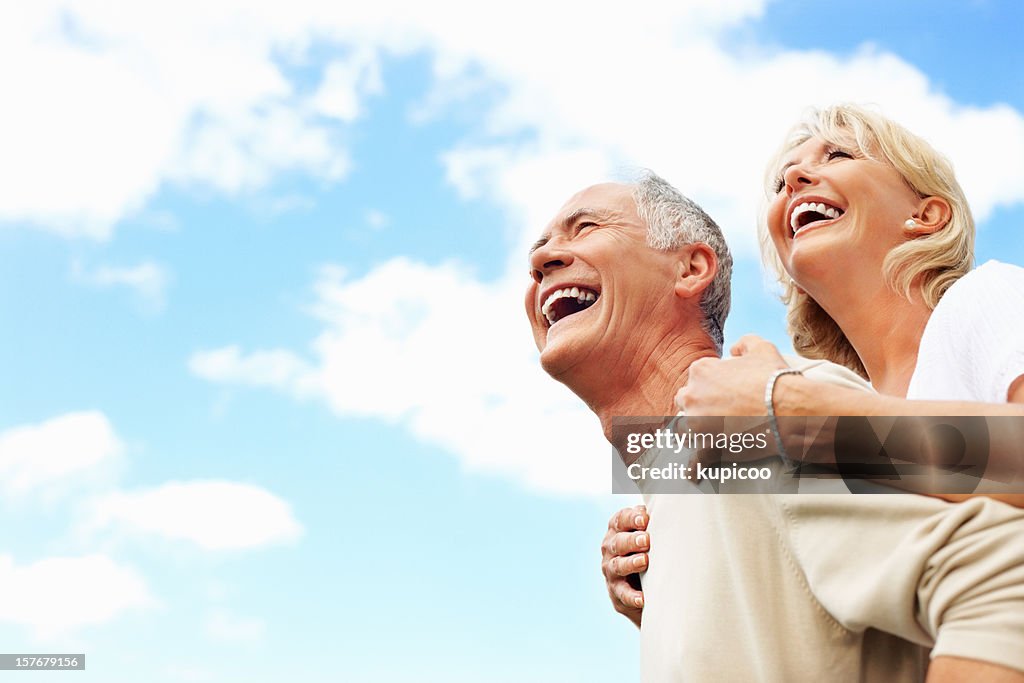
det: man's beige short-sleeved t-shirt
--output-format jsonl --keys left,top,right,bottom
{"left": 641, "top": 361, "right": 1024, "bottom": 683}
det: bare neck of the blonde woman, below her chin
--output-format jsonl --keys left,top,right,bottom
{"left": 818, "top": 278, "right": 932, "bottom": 396}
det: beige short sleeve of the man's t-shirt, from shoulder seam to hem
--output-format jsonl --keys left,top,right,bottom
{"left": 782, "top": 494, "right": 1024, "bottom": 671}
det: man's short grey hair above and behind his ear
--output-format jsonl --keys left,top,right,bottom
{"left": 633, "top": 171, "right": 732, "bottom": 351}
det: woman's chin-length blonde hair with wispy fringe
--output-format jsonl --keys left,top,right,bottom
{"left": 758, "top": 104, "right": 975, "bottom": 377}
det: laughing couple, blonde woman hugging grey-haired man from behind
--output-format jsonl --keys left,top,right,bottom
{"left": 525, "top": 105, "right": 1024, "bottom": 683}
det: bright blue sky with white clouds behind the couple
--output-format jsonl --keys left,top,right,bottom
{"left": 6, "top": 0, "right": 1024, "bottom": 682}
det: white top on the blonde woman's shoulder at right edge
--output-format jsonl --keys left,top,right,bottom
{"left": 906, "top": 261, "right": 1024, "bottom": 403}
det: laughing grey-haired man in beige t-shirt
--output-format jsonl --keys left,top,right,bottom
{"left": 526, "top": 174, "right": 1024, "bottom": 683}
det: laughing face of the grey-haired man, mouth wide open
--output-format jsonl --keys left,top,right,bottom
{"left": 525, "top": 183, "right": 678, "bottom": 381}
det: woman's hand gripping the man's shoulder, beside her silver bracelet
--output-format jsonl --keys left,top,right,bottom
{"left": 676, "top": 335, "right": 787, "bottom": 417}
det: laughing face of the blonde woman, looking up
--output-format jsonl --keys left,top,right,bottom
{"left": 768, "top": 137, "right": 921, "bottom": 298}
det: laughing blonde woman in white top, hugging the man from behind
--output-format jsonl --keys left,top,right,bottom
{"left": 602, "top": 100, "right": 1024, "bottom": 623}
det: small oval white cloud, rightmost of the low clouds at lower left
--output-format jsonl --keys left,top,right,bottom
{"left": 83, "top": 481, "right": 303, "bottom": 551}
